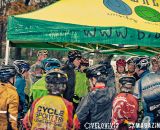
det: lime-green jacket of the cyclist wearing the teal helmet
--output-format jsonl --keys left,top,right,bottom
{"left": 30, "top": 74, "right": 48, "bottom": 101}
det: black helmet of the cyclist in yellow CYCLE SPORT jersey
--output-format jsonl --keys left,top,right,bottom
{"left": 46, "top": 71, "right": 67, "bottom": 84}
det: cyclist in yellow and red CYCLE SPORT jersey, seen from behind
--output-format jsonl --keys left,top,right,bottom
{"left": 23, "top": 71, "right": 73, "bottom": 130}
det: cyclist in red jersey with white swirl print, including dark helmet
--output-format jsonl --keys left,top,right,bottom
{"left": 112, "top": 75, "right": 138, "bottom": 129}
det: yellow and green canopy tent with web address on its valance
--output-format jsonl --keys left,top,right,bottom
{"left": 7, "top": 0, "right": 160, "bottom": 60}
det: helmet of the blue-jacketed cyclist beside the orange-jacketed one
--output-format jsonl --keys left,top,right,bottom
{"left": 13, "top": 60, "right": 30, "bottom": 74}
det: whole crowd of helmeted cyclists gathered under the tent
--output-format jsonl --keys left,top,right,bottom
{"left": 0, "top": 50, "right": 160, "bottom": 130}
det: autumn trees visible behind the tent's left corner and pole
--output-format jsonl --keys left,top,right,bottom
{"left": 0, "top": 0, "right": 58, "bottom": 59}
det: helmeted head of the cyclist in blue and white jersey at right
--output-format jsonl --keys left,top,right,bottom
{"left": 134, "top": 56, "right": 150, "bottom": 75}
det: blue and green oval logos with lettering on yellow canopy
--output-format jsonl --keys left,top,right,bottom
{"left": 103, "top": 0, "right": 160, "bottom": 22}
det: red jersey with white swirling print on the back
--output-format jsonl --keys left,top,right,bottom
{"left": 112, "top": 93, "right": 138, "bottom": 124}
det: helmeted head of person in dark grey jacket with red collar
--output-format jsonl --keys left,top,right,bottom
{"left": 86, "top": 64, "right": 108, "bottom": 88}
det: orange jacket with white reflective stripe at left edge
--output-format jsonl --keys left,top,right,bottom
{"left": 0, "top": 83, "right": 19, "bottom": 130}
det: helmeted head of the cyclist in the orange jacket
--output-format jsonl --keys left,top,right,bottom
{"left": 0, "top": 65, "right": 17, "bottom": 85}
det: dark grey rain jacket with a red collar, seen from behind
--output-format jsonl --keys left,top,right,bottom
{"left": 74, "top": 86, "right": 115, "bottom": 129}
